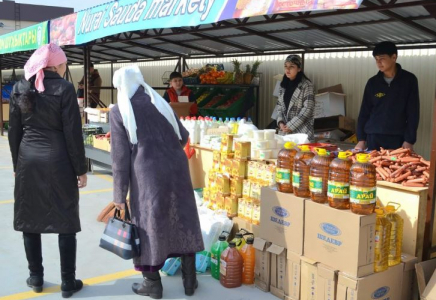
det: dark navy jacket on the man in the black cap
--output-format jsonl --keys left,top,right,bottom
{"left": 357, "top": 64, "right": 419, "bottom": 144}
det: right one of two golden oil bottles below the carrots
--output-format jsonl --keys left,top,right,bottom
{"left": 385, "top": 202, "right": 404, "bottom": 267}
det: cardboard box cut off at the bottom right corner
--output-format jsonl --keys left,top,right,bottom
{"left": 415, "top": 259, "right": 436, "bottom": 300}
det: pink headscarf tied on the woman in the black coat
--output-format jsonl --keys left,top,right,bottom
{"left": 24, "top": 43, "right": 67, "bottom": 92}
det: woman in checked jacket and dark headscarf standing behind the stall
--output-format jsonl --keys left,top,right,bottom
{"left": 277, "top": 55, "right": 315, "bottom": 141}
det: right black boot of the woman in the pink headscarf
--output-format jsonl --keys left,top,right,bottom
{"left": 59, "top": 233, "right": 83, "bottom": 298}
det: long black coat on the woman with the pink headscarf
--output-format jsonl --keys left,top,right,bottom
{"left": 8, "top": 71, "right": 87, "bottom": 233}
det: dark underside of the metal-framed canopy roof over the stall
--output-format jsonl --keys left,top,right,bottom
{"left": 0, "top": 0, "right": 436, "bottom": 69}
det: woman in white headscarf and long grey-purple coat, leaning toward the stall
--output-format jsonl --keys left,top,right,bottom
{"left": 110, "top": 66, "right": 204, "bottom": 299}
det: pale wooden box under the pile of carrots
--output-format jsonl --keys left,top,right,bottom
{"left": 377, "top": 181, "right": 428, "bottom": 261}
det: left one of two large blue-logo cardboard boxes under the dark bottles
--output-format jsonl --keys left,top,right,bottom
{"left": 260, "top": 187, "right": 305, "bottom": 255}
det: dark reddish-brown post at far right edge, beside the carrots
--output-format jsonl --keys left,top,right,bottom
{"left": 422, "top": 87, "right": 436, "bottom": 260}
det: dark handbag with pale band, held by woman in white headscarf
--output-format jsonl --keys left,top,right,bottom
{"left": 100, "top": 207, "right": 141, "bottom": 260}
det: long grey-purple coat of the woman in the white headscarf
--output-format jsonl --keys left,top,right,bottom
{"left": 110, "top": 87, "right": 204, "bottom": 266}
